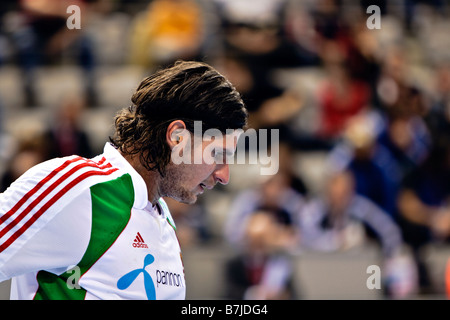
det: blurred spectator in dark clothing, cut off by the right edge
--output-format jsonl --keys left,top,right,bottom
{"left": 398, "top": 145, "right": 450, "bottom": 293}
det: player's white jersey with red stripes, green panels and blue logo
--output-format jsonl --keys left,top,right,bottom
{"left": 0, "top": 143, "right": 186, "bottom": 300}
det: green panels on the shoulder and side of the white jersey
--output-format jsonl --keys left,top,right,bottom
{"left": 34, "top": 174, "right": 134, "bottom": 300}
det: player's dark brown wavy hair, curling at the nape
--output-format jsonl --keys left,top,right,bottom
{"left": 110, "top": 60, "right": 248, "bottom": 175}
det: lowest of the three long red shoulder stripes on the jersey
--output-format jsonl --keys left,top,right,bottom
{"left": 0, "top": 168, "right": 119, "bottom": 253}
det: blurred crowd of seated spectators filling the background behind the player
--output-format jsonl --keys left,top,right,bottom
{"left": 0, "top": 0, "right": 450, "bottom": 299}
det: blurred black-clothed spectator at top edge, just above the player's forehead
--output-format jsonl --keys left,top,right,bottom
{"left": 211, "top": 0, "right": 315, "bottom": 137}
